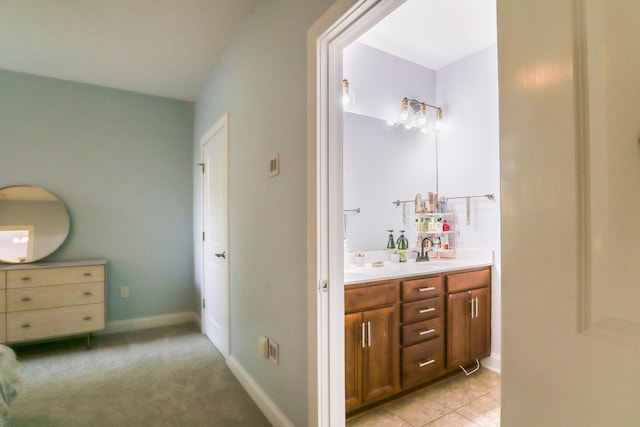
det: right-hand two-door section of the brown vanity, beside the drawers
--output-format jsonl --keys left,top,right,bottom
{"left": 445, "top": 268, "right": 491, "bottom": 369}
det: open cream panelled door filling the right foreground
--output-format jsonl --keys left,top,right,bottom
{"left": 497, "top": 0, "right": 640, "bottom": 427}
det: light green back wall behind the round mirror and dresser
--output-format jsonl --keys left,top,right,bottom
{"left": 0, "top": 70, "right": 194, "bottom": 321}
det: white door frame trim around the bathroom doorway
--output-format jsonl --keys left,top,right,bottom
{"left": 307, "top": 0, "right": 406, "bottom": 427}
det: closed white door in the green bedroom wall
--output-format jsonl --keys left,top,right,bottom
{"left": 202, "top": 115, "right": 230, "bottom": 358}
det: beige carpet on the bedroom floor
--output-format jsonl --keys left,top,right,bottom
{"left": 7, "top": 325, "right": 270, "bottom": 427}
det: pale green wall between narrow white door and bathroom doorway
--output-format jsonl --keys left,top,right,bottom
{"left": 194, "top": 0, "right": 333, "bottom": 426}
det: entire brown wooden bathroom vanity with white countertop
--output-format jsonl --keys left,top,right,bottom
{"left": 345, "top": 260, "right": 491, "bottom": 413}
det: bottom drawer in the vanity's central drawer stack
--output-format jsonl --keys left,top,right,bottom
{"left": 402, "top": 338, "right": 443, "bottom": 388}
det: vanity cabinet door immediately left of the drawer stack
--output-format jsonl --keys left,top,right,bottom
{"left": 363, "top": 307, "right": 400, "bottom": 402}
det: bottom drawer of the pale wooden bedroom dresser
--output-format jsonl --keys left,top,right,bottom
{"left": 7, "top": 304, "right": 105, "bottom": 342}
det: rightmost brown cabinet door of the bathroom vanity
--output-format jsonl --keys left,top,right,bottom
{"left": 469, "top": 288, "right": 491, "bottom": 361}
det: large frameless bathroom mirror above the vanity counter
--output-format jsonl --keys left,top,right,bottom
{"left": 343, "top": 112, "right": 436, "bottom": 251}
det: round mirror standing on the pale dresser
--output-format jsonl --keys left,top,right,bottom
{"left": 0, "top": 185, "right": 69, "bottom": 264}
